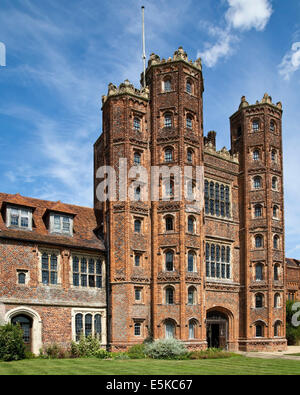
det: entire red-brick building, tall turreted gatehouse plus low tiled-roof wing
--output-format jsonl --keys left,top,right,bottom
{"left": 0, "top": 48, "right": 300, "bottom": 351}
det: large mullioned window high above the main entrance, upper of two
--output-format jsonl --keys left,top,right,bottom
{"left": 204, "top": 180, "right": 231, "bottom": 218}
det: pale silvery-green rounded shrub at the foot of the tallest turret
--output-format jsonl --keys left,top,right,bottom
{"left": 145, "top": 339, "right": 188, "bottom": 359}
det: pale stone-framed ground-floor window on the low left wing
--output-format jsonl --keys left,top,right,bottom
{"left": 75, "top": 312, "right": 102, "bottom": 342}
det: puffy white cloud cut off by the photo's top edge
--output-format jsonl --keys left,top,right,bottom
{"left": 225, "top": 0, "right": 273, "bottom": 31}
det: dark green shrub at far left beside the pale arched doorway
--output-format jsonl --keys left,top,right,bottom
{"left": 0, "top": 324, "right": 25, "bottom": 361}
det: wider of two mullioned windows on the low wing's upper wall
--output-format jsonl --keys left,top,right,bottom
{"left": 73, "top": 256, "right": 102, "bottom": 288}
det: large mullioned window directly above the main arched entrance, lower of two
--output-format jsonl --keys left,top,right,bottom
{"left": 205, "top": 243, "right": 231, "bottom": 280}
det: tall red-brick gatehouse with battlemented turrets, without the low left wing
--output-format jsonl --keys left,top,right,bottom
{"left": 94, "top": 48, "right": 286, "bottom": 350}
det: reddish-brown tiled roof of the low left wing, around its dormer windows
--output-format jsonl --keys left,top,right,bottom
{"left": 0, "top": 193, "right": 105, "bottom": 251}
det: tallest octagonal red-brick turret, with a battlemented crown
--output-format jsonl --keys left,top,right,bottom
{"left": 146, "top": 47, "right": 206, "bottom": 346}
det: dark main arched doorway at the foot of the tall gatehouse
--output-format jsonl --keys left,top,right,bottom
{"left": 206, "top": 310, "right": 229, "bottom": 349}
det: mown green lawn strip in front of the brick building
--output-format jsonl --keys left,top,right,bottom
{"left": 0, "top": 356, "right": 300, "bottom": 375}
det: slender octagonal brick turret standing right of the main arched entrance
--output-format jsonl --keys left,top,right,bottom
{"left": 230, "top": 94, "right": 286, "bottom": 350}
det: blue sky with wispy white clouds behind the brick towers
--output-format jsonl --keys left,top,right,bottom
{"left": 0, "top": 0, "right": 300, "bottom": 259}
